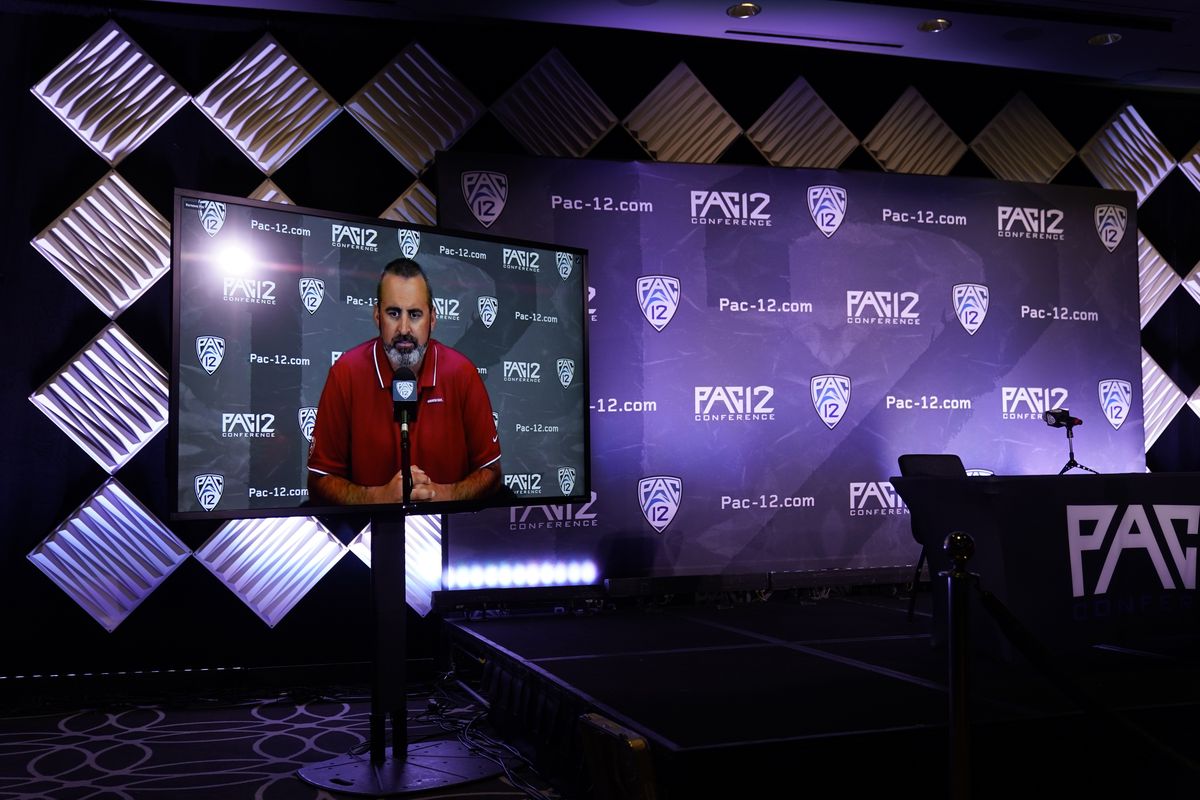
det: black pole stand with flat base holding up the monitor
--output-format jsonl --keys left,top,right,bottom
{"left": 296, "top": 506, "right": 503, "bottom": 798}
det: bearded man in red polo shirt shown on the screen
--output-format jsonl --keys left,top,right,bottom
{"left": 308, "top": 259, "right": 500, "bottom": 505}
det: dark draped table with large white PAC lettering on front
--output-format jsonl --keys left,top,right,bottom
{"left": 892, "top": 473, "right": 1200, "bottom": 660}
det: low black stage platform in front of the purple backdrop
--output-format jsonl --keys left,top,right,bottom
{"left": 440, "top": 587, "right": 1200, "bottom": 800}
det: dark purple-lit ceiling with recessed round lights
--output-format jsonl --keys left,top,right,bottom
{"left": 142, "top": 0, "right": 1200, "bottom": 90}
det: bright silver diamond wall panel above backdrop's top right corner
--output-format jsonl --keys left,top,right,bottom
{"left": 1079, "top": 104, "right": 1175, "bottom": 206}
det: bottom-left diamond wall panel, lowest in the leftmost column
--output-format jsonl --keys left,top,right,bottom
{"left": 28, "top": 479, "right": 190, "bottom": 631}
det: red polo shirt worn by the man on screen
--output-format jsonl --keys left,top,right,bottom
{"left": 308, "top": 338, "right": 500, "bottom": 486}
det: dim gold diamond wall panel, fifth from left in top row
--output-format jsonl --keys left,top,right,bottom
{"left": 624, "top": 64, "right": 742, "bottom": 164}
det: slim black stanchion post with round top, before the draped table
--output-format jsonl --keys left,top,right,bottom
{"left": 942, "top": 531, "right": 974, "bottom": 800}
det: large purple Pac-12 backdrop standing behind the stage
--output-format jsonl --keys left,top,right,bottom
{"left": 438, "top": 152, "right": 1146, "bottom": 588}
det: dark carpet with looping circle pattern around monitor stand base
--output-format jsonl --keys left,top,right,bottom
{"left": 0, "top": 684, "right": 562, "bottom": 800}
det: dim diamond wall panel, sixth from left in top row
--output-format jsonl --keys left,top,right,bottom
{"left": 746, "top": 78, "right": 858, "bottom": 169}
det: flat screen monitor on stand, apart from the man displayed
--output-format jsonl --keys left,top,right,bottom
{"left": 168, "top": 190, "right": 592, "bottom": 519}
